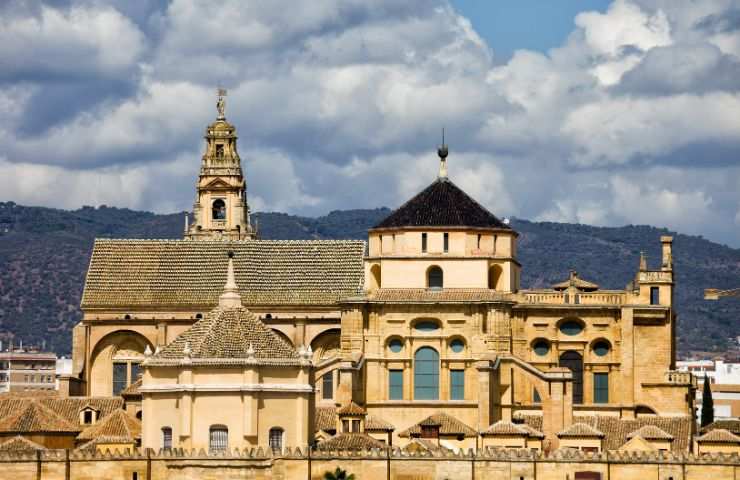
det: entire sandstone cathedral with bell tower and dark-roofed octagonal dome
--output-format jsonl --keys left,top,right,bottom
{"left": 64, "top": 93, "right": 704, "bottom": 452}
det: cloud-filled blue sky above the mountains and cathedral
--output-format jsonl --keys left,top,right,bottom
{"left": 0, "top": 0, "right": 740, "bottom": 247}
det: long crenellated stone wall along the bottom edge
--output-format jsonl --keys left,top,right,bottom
{"left": 5, "top": 448, "right": 740, "bottom": 480}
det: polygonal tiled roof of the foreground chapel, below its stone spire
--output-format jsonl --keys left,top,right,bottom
{"left": 146, "top": 307, "right": 300, "bottom": 365}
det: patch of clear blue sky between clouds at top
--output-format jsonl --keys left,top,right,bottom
{"left": 452, "top": 0, "right": 611, "bottom": 61}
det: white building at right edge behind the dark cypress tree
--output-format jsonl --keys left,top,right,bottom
{"left": 676, "top": 360, "right": 740, "bottom": 420}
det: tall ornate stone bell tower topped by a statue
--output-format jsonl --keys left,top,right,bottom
{"left": 185, "top": 89, "right": 254, "bottom": 240}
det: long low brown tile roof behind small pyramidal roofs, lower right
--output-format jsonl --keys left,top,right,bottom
{"left": 515, "top": 414, "right": 692, "bottom": 452}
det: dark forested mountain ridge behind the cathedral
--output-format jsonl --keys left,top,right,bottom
{"left": 0, "top": 202, "right": 740, "bottom": 355}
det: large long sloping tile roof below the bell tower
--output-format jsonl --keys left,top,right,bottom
{"left": 82, "top": 239, "right": 365, "bottom": 310}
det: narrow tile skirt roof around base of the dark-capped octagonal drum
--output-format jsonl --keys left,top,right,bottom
{"left": 366, "top": 288, "right": 510, "bottom": 303}
